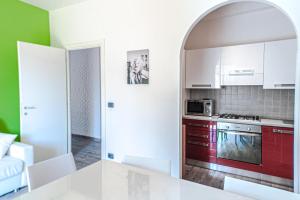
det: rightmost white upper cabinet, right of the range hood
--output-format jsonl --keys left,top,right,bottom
{"left": 264, "top": 39, "right": 297, "bottom": 89}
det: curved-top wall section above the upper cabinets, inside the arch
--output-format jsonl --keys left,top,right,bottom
{"left": 185, "top": 3, "right": 296, "bottom": 49}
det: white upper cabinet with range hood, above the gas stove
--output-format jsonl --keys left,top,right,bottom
{"left": 221, "top": 43, "right": 264, "bottom": 85}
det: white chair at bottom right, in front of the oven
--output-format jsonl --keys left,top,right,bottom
{"left": 224, "top": 177, "right": 300, "bottom": 200}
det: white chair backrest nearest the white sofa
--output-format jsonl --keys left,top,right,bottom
{"left": 27, "top": 153, "right": 76, "bottom": 192}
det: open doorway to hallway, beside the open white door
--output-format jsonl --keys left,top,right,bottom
{"left": 68, "top": 47, "right": 102, "bottom": 169}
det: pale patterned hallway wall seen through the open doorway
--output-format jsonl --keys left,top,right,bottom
{"left": 69, "top": 48, "right": 101, "bottom": 139}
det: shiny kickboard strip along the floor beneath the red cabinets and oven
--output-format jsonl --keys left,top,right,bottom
{"left": 186, "top": 159, "right": 294, "bottom": 187}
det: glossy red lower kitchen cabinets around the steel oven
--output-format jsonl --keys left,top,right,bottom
{"left": 183, "top": 119, "right": 294, "bottom": 179}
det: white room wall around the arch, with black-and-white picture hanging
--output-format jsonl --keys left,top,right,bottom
{"left": 50, "top": 0, "right": 300, "bottom": 176}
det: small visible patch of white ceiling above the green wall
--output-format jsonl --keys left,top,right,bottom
{"left": 20, "top": 0, "right": 87, "bottom": 11}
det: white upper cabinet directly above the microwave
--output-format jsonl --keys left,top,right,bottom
{"left": 185, "top": 48, "right": 221, "bottom": 89}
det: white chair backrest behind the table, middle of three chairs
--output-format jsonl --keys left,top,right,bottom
{"left": 122, "top": 156, "right": 171, "bottom": 175}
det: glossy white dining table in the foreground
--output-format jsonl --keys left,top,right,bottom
{"left": 16, "top": 160, "right": 250, "bottom": 200}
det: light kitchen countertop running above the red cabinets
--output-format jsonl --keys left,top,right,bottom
{"left": 183, "top": 115, "right": 294, "bottom": 128}
